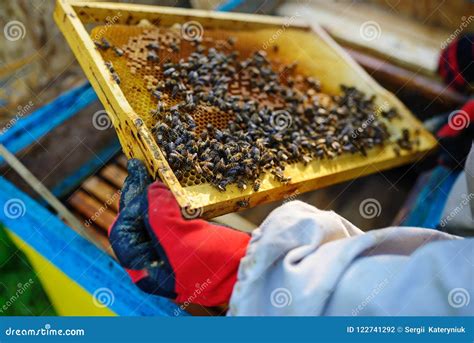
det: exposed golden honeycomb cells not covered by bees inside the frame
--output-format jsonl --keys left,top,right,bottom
{"left": 91, "top": 25, "right": 418, "bottom": 194}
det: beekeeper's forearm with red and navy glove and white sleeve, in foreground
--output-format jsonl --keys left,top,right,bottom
{"left": 109, "top": 160, "right": 473, "bottom": 315}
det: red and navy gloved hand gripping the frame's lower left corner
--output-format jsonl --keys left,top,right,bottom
{"left": 109, "top": 159, "right": 250, "bottom": 306}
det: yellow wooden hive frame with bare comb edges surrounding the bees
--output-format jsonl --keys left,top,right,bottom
{"left": 55, "top": 0, "right": 436, "bottom": 218}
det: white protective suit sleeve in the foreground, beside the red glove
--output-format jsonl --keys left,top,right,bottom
{"left": 228, "top": 201, "right": 474, "bottom": 316}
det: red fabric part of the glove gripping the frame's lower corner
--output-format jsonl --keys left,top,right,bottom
{"left": 148, "top": 183, "right": 250, "bottom": 306}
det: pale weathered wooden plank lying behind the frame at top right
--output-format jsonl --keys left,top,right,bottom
{"left": 277, "top": 0, "right": 452, "bottom": 77}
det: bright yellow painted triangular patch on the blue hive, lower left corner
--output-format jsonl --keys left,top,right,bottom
{"left": 7, "top": 230, "right": 116, "bottom": 316}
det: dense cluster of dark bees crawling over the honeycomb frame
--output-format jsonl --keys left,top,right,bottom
{"left": 95, "top": 27, "right": 413, "bottom": 191}
